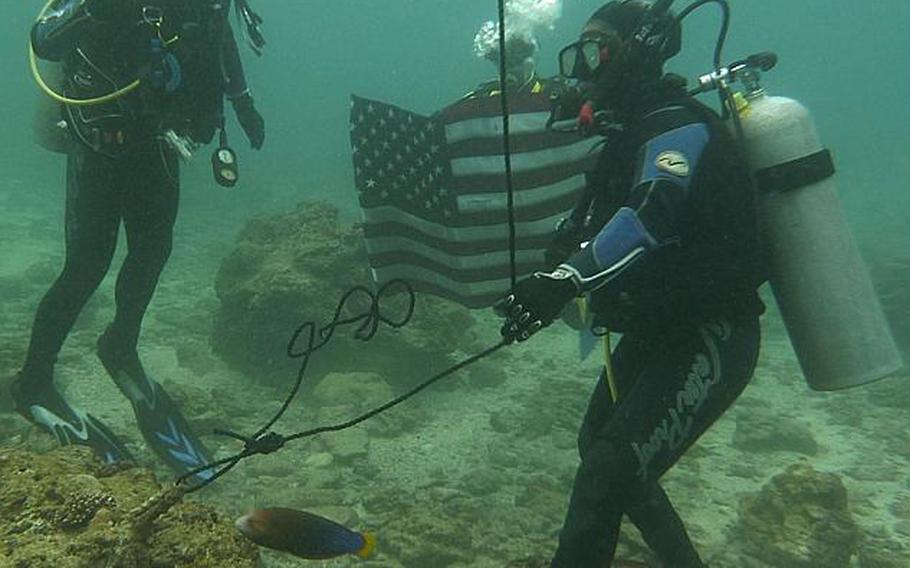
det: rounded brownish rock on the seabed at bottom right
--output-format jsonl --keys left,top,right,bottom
{"left": 732, "top": 464, "right": 861, "bottom": 568}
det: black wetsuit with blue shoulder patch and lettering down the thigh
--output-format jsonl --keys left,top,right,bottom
{"left": 553, "top": 91, "right": 763, "bottom": 568}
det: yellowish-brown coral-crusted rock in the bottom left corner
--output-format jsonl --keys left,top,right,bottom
{"left": 0, "top": 446, "right": 260, "bottom": 568}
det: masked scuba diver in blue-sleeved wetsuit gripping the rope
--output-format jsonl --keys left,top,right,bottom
{"left": 496, "top": 0, "right": 764, "bottom": 568}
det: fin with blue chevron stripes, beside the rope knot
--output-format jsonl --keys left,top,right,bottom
{"left": 98, "top": 334, "right": 214, "bottom": 483}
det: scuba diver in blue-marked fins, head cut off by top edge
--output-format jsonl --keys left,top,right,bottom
{"left": 12, "top": 0, "right": 265, "bottom": 480}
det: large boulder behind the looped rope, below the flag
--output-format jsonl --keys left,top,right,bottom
{"left": 212, "top": 201, "right": 474, "bottom": 390}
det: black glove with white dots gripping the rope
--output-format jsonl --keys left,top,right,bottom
{"left": 493, "top": 267, "right": 579, "bottom": 342}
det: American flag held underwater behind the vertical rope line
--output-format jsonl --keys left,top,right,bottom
{"left": 350, "top": 84, "right": 598, "bottom": 308}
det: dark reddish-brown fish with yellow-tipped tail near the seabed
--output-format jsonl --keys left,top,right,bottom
{"left": 234, "top": 507, "right": 376, "bottom": 560}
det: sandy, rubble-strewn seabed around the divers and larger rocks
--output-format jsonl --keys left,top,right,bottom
{"left": 0, "top": 181, "right": 910, "bottom": 568}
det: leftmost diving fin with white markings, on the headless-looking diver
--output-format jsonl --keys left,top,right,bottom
{"left": 11, "top": 374, "right": 135, "bottom": 464}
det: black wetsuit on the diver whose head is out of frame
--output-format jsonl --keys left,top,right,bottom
{"left": 21, "top": 0, "right": 247, "bottom": 395}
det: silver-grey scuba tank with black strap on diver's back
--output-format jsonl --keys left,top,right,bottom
{"left": 696, "top": 53, "right": 903, "bottom": 391}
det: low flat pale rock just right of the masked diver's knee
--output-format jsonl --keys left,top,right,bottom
{"left": 733, "top": 409, "right": 818, "bottom": 456}
